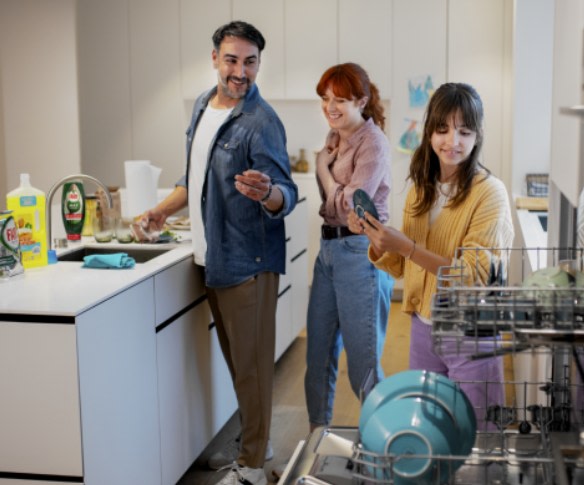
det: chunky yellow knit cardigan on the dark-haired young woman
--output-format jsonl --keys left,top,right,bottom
{"left": 369, "top": 173, "right": 513, "bottom": 318}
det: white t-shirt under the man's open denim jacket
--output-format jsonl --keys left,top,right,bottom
{"left": 189, "top": 106, "right": 233, "bottom": 266}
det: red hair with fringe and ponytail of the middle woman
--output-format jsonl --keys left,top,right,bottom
{"left": 316, "top": 62, "right": 385, "bottom": 130}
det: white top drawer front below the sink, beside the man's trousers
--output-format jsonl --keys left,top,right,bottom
{"left": 154, "top": 256, "right": 205, "bottom": 326}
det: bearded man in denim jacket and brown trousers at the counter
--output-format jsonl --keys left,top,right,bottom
{"left": 143, "top": 21, "right": 298, "bottom": 485}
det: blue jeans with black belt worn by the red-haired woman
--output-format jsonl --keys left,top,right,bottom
{"left": 304, "top": 236, "right": 394, "bottom": 426}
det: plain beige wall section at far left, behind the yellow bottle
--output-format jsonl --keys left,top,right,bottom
{"left": 0, "top": 0, "right": 81, "bottom": 197}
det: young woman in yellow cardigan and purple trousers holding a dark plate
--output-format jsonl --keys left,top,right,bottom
{"left": 349, "top": 83, "right": 513, "bottom": 428}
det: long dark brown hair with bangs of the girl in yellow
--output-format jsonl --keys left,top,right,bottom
{"left": 408, "top": 83, "right": 490, "bottom": 216}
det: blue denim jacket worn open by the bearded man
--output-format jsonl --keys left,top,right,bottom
{"left": 177, "top": 85, "right": 298, "bottom": 288}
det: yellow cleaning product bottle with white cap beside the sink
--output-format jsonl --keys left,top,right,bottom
{"left": 6, "top": 173, "right": 48, "bottom": 268}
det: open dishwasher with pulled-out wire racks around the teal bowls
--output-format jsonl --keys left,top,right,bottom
{"left": 278, "top": 248, "right": 584, "bottom": 485}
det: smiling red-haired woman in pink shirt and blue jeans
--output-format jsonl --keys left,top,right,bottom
{"left": 305, "top": 63, "right": 393, "bottom": 431}
